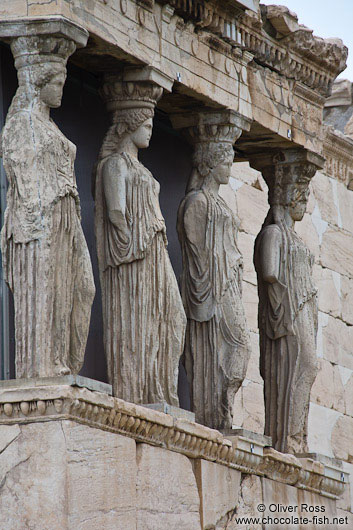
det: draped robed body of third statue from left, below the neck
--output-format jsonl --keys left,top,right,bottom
{"left": 178, "top": 189, "right": 250, "bottom": 429}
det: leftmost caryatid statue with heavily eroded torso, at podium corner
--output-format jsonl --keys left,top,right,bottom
{"left": 1, "top": 21, "right": 95, "bottom": 378}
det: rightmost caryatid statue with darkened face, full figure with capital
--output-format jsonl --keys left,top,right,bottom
{"left": 251, "top": 149, "right": 322, "bottom": 453}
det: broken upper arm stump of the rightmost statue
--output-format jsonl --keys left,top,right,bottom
{"left": 260, "top": 225, "right": 282, "bottom": 283}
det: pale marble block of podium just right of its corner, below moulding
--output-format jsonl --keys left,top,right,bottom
{"left": 62, "top": 422, "right": 137, "bottom": 530}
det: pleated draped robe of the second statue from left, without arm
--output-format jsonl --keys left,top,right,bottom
{"left": 95, "top": 153, "right": 186, "bottom": 406}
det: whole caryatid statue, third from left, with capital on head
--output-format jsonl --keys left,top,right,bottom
{"left": 178, "top": 112, "right": 250, "bottom": 429}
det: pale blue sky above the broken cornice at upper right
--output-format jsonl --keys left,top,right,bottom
{"left": 260, "top": 0, "right": 353, "bottom": 82}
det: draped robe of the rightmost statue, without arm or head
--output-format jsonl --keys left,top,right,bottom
{"left": 255, "top": 224, "right": 318, "bottom": 453}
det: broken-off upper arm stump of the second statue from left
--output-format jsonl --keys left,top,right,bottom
{"left": 103, "top": 156, "right": 129, "bottom": 236}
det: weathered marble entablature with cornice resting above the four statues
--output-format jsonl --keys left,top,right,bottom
{"left": 0, "top": 0, "right": 347, "bottom": 157}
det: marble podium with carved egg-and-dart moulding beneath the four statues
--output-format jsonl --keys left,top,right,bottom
{"left": 0, "top": 385, "right": 347, "bottom": 530}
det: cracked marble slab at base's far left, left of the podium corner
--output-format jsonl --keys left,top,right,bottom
{"left": 0, "top": 422, "right": 67, "bottom": 530}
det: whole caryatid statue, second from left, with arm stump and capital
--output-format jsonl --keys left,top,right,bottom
{"left": 95, "top": 71, "right": 186, "bottom": 406}
